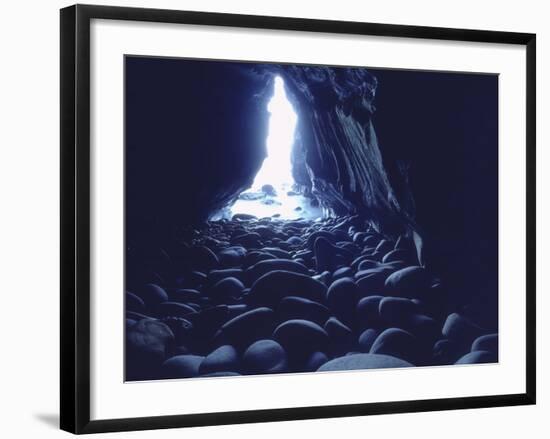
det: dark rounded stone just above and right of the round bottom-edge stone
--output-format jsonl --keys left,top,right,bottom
{"left": 273, "top": 319, "right": 328, "bottom": 354}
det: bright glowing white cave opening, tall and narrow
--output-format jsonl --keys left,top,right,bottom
{"left": 229, "top": 75, "right": 323, "bottom": 220}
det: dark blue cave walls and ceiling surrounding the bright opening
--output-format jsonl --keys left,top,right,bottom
{"left": 125, "top": 57, "right": 498, "bottom": 382}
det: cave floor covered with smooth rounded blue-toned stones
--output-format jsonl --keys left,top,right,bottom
{"left": 125, "top": 215, "right": 498, "bottom": 380}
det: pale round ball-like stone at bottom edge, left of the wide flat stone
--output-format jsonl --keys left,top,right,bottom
{"left": 243, "top": 340, "right": 288, "bottom": 374}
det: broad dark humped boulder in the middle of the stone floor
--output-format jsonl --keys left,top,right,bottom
{"left": 248, "top": 271, "right": 327, "bottom": 307}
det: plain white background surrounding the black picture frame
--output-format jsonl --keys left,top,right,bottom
{"left": 0, "top": 0, "right": 550, "bottom": 439}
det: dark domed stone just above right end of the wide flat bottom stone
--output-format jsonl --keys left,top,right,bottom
{"left": 370, "top": 328, "right": 427, "bottom": 364}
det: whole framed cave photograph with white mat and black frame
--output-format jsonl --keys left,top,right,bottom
{"left": 61, "top": 5, "right": 536, "bottom": 433}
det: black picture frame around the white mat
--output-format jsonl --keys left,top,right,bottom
{"left": 60, "top": 5, "right": 536, "bottom": 434}
